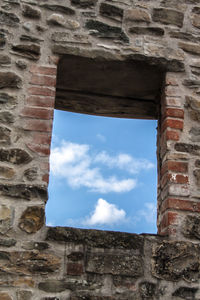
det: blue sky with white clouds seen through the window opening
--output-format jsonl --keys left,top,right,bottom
{"left": 46, "top": 110, "right": 157, "bottom": 233}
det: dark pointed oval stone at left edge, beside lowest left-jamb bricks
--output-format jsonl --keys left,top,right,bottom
{"left": 0, "top": 148, "right": 32, "bottom": 165}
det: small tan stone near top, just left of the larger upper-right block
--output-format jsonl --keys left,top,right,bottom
{"left": 124, "top": 8, "right": 151, "bottom": 23}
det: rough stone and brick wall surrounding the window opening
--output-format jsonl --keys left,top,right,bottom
{"left": 0, "top": 0, "right": 200, "bottom": 300}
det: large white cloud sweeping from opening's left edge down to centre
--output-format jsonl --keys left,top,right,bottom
{"left": 50, "top": 141, "right": 136, "bottom": 193}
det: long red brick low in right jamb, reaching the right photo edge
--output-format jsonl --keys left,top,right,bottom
{"left": 161, "top": 198, "right": 200, "bottom": 213}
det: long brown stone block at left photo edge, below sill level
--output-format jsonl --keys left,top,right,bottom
{"left": 0, "top": 251, "right": 60, "bottom": 276}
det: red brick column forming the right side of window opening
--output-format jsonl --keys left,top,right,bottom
{"left": 157, "top": 73, "right": 188, "bottom": 238}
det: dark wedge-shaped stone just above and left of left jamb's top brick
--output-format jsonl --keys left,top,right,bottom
{"left": 12, "top": 44, "right": 40, "bottom": 60}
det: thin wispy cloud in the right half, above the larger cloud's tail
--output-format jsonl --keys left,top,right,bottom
{"left": 95, "top": 151, "right": 155, "bottom": 174}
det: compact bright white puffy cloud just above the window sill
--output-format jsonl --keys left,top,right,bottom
{"left": 83, "top": 198, "right": 126, "bottom": 226}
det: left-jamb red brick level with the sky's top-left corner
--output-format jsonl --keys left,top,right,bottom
{"left": 20, "top": 106, "right": 53, "bottom": 120}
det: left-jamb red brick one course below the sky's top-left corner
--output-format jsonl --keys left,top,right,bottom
{"left": 23, "top": 119, "right": 52, "bottom": 132}
